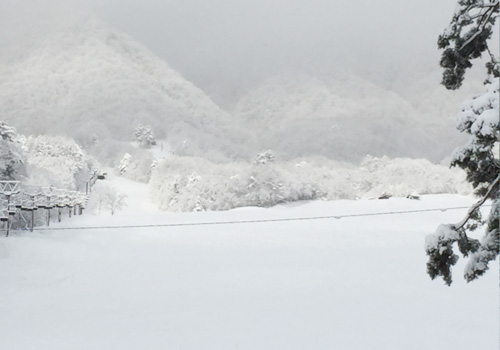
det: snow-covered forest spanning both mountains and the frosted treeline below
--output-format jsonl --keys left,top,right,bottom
{"left": 0, "top": 17, "right": 480, "bottom": 211}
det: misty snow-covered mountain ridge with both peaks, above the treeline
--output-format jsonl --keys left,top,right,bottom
{"left": 0, "top": 18, "right": 472, "bottom": 161}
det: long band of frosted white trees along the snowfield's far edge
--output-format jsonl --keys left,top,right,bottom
{"left": 150, "top": 154, "right": 471, "bottom": 211}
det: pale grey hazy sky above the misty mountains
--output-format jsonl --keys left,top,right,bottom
{"left": 0, "top": 0, "right": 492, "bottom": 104}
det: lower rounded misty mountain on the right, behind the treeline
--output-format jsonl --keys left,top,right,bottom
{"left": 234, "top": 73, "right": 468, "bottom": 161}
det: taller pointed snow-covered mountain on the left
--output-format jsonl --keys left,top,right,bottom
{"left": 0, "top": 18, "right": 247, "bottom": 161}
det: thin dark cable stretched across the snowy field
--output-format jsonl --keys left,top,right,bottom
{"left": 37, "top": 205, "right": 491, "bottom": 231}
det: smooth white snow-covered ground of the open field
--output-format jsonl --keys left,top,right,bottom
{"left": 0, "top": 178, "right": 499, "bottom": 350}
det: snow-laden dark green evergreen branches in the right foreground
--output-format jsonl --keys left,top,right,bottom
{"left": 426, "top": 0, "right": 500, "bottom": 285}
